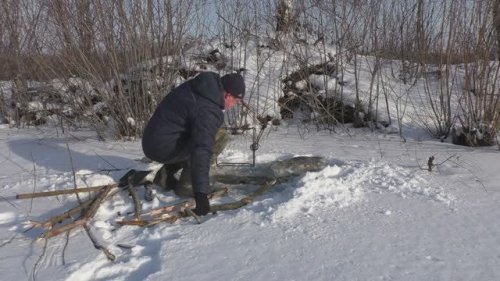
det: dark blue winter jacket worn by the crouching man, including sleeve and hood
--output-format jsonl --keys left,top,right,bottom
{"left": 142, "top": 72, "right": 224, "bottom": 194}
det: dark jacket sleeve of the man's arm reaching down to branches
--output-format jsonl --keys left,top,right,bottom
{"left": 191, "top": 101, "right": 224, "bottom": 194}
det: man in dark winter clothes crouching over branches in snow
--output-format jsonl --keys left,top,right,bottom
{"left": 142, "top": 72, "right": 245, "bottom": 215}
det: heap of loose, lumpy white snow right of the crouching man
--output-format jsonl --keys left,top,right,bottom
{"left": 272, "top": 162, "right": 453, "bottom": 221}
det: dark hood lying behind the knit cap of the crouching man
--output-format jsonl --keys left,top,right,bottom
{"left": 189, "top": 72, "right": 224, "bottom": 109}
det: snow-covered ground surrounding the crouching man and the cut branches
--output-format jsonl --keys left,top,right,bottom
{"left": 0, "top": 123, "right": 500, "bottom": 281}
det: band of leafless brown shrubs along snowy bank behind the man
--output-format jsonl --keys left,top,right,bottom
{"left": 0, "top": 0, "right": 500, "bottom": 143}
